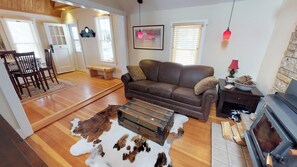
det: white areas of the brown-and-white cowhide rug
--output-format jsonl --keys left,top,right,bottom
{"left": 70, "top": 114, "right": 188, "bottom": 167}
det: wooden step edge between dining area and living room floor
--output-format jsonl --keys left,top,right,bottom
{"left": 32, "top": 83, "right": 124, "bottom": 132}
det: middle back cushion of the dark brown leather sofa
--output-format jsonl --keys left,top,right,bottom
{"left": 158, "top": 62, "right": 183, "bottom": 85}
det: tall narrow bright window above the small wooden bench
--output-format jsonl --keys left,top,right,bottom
{"left": 96, "top": 16, "right": 114, "bottom": 63}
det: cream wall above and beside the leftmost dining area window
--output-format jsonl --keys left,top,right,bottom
{"left": 0, "top": 9, "right": 60, "bottom": 50}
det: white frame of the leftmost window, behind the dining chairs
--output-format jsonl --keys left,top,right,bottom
{"left": 1, "top": 18, "right": 45, "bottom": 62}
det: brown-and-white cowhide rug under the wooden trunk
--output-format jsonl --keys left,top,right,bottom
{"left": 70, "top": 105, "right": 188, "bottom": 167}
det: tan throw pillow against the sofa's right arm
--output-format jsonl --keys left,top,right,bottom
{"left": 194, "top": 76, "right": 219, "bottom": 95}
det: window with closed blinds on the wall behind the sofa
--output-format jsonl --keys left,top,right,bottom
{"left": 172, "top": 23, "right": 203, "bottom": 65}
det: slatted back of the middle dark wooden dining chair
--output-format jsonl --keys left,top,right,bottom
{"left": 14, "top": 52, "right": 38, "bottom": 74}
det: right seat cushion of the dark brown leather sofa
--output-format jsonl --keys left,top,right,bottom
{"left": 172, "top": 87, "right": 202, "bottom": 107}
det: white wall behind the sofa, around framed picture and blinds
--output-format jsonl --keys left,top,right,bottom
{"left": 128, "top": 0, "right": 283, "bottom": 87}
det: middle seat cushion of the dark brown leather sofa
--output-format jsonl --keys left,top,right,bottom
{"left": 148, "top": 83, "right": 177, "bottom": 99}
